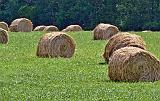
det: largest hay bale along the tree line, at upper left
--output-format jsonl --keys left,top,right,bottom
{"left": 10, "top": 18, "right": 33, "bottom": 32}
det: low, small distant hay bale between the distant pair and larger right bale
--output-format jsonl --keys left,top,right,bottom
{"left": 62, "top": 25, "right": 83, "bottom": 32}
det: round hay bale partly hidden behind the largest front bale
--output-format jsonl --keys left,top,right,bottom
{"left": 103, "top": 33, "right": 146, "bottom": 63}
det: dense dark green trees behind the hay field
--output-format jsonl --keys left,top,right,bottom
{"left": 0, "top": 0, "right": 160, "bottom": 30}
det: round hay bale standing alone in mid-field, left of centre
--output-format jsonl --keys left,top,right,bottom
{"left": 37, "top": 32, "right": 76, "bottom": 58}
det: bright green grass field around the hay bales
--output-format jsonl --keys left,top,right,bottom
{"left": 0, "top": 32, "right": 160, "bottom": 101}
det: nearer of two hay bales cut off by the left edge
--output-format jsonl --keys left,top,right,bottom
{"left": 0, "top": 28, "right": 8, "bottom": 44}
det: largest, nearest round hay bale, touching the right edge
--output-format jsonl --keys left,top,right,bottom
{"left": 108, "top": 47, "right": 160, "bottom": 82}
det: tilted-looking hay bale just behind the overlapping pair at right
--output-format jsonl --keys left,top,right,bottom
{"left": 93, "top": 23, "right": 119, "bottom": 40}
